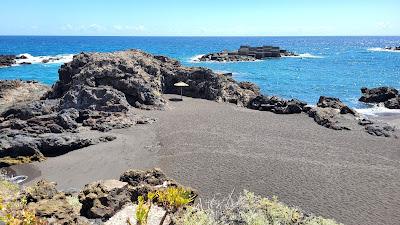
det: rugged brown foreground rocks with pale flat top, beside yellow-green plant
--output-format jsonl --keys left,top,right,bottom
{"left": 79, "top": 169, "right": 197, "bottom": 220}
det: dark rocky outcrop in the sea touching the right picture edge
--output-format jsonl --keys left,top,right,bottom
{"left": 359, "top": 87, "right": 400, "bottom": 109}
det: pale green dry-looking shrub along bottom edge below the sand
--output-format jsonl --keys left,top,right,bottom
{"left": 175, "top": 191, "right": 339, "bottom": 225}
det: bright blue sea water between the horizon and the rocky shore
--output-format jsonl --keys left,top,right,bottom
{"left": 0, "top": 36, "right": 400, "bottom": 108}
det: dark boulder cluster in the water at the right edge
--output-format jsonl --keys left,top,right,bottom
{"left": 359, "top": 87, "right": 399, "bottom": 103}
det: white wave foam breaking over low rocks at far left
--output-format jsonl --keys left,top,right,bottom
{"left": 16, "top": 53, "right": 74, "bottom": 65}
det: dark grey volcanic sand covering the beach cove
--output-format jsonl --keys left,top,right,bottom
{"left": 13, "top": 96, "right": 400, "bottom": 225}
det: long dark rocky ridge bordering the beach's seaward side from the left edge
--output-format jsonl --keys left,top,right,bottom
{"left": 0, "top": 50, "right": 396, "bottom": 169}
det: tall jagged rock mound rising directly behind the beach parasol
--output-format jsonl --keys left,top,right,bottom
{"left": 47, "top": 50, "right": 259, "bottom": 108}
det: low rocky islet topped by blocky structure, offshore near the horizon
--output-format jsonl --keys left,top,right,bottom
{"left": 199, "top": 45, "right": 297, "bottom": 62}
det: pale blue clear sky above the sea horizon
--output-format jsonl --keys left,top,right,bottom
{"left": 0, "top": 0, "right": 400, "bottom": 36}
